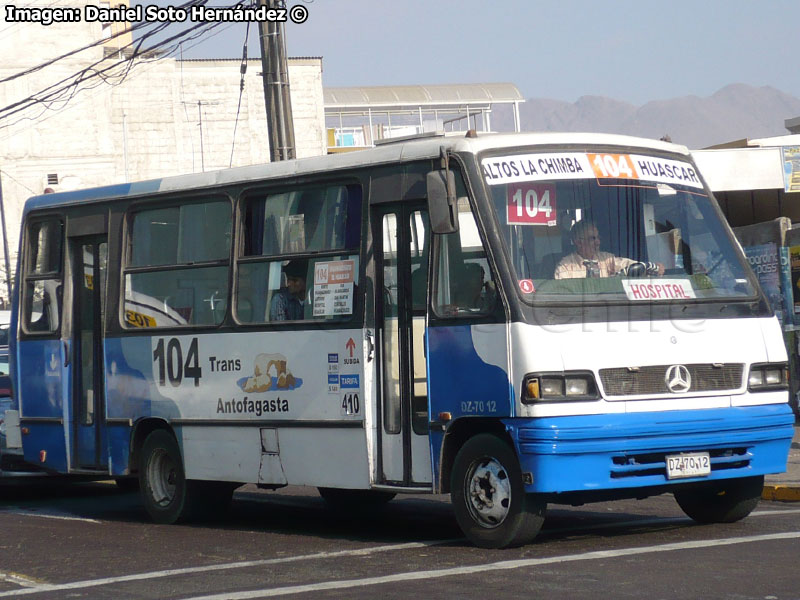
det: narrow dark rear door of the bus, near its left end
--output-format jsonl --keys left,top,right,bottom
{"left": 69, "top": 235, "right": 108, "bottom": 470}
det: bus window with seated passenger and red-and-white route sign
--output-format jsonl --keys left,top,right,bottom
{"left": 236, "top": 185, "right": 361, "bottom": 323}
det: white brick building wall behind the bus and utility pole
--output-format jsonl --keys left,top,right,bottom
{"left": 0, "top": 2, "right": 326, "bottom": 300}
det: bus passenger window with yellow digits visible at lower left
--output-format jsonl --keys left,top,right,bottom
{"left": 124, "top": 200, "right": 232, "bottom": 328}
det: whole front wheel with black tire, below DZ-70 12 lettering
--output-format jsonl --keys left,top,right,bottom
{"left": 450, "top": 433, "right": 547, "bottom": 548}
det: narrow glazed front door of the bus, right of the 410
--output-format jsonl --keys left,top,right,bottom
{"left": 372, "top": 203, "right": 432, "bottom": 486}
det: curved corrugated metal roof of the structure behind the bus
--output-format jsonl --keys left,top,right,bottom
{"left": 323, "top": 83, "right": 525, "bottom": 109}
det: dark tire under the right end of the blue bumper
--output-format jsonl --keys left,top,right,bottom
{"left": 674, "top": 475, "right": 764, "bottom": 523}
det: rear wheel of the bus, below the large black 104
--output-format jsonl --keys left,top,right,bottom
{"left": 139, "top": 429, "right": 193, "bottom": 524}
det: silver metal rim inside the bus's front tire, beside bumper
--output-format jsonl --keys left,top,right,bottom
{"left": 466, "top": 458, "right": 511, "bottom": 527}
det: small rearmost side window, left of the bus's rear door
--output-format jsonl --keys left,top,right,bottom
{"left": 23, "top": 219, "right": 64, "bottom": 333}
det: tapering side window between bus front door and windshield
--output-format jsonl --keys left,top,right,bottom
{"left": 433, "top": 198, "right": 497, "bottom": 317}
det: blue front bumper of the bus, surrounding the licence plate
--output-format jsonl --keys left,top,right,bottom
{"left": 510, "top": 404, "right": 794, "bottom": 493}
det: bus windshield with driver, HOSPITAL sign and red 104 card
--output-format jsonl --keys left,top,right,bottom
{"left": 481, "top": 152, "right": 756, "bottom": 303}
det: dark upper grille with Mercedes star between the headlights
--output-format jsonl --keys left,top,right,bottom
{"left": 600, "top": 363, "right": 744, "bottom": 396}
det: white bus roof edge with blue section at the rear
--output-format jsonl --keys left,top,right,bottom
{"left": 25, "top": 132, "right": 689, "bottom": 213}
